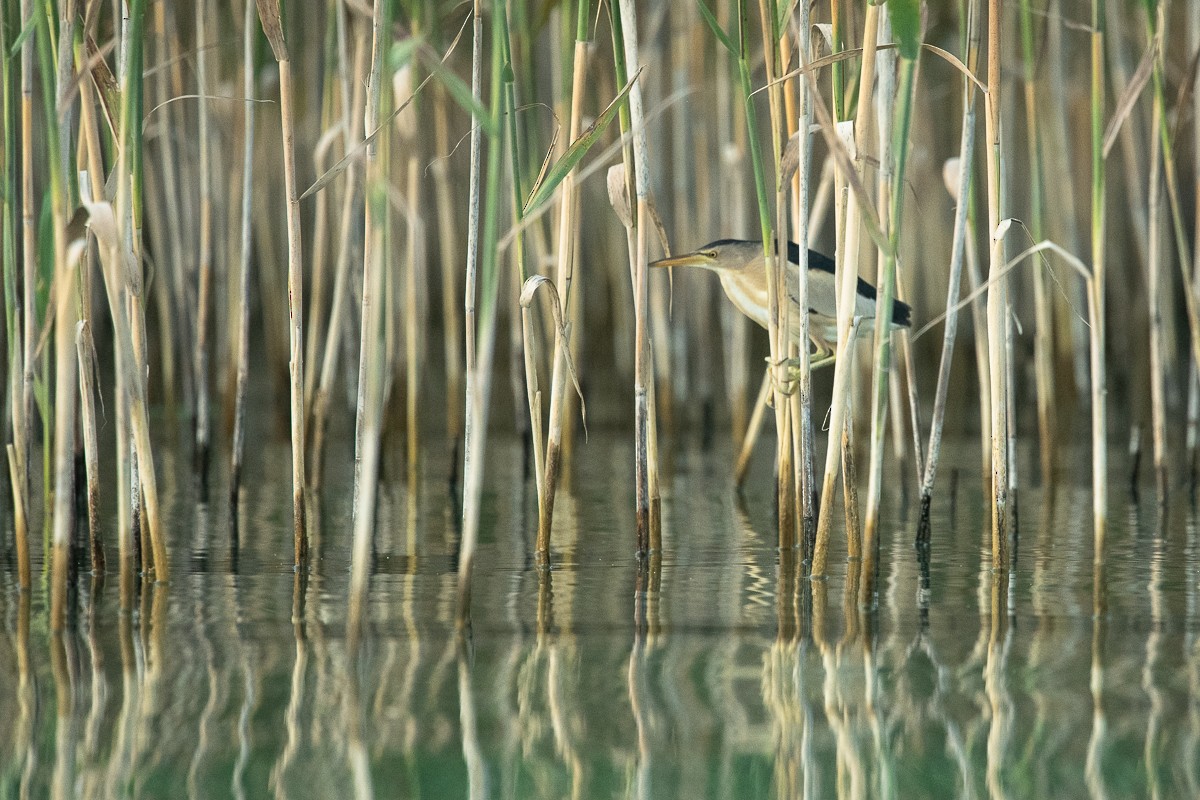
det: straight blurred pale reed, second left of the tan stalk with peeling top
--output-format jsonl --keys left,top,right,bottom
{"left": 194, "top": 0, "right": 213, "bottom": 472}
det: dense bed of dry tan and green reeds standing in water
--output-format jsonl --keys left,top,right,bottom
{"left": 0, "top": 0, "right": 1200, "bottom": 620}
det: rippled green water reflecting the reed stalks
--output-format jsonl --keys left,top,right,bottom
{"left": 0, "top": 432, "right": 1200, "bottom": 799}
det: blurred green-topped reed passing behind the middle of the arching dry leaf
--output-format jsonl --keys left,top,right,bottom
{"left": 1020, "top": 0, "right": 1057, "bottom": 487}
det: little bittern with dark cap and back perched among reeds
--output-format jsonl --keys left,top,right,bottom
{"left": 650, "top": 239, "right": 911, "bottom": 368}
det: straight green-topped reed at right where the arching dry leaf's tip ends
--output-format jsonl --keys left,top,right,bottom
{"left": 1091, "top": 0, "right": 1109, "bottom": 546}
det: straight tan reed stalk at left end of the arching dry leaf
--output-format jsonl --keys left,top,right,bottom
{"left": 984, "top": 0, "right": 1008, "bottom": 570}
